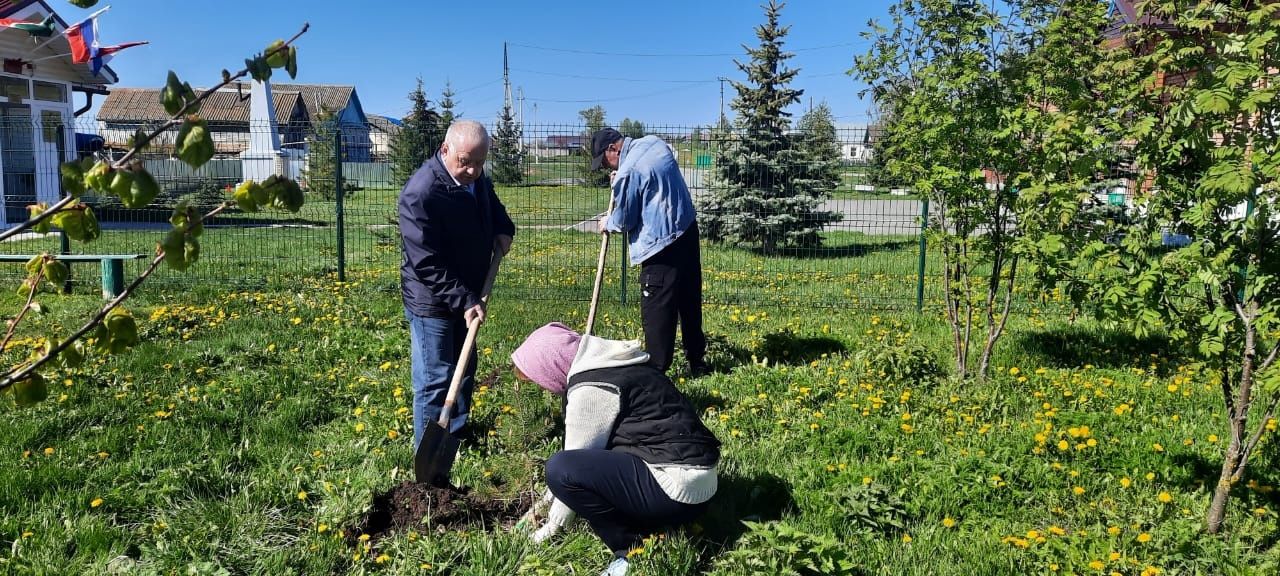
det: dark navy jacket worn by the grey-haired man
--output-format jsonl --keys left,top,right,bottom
{"left": 399, "top": 154, "right": 516, "bottom": 317}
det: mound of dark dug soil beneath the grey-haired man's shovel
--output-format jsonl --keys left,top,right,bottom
{"left": 344, "top": 480, "right": 532, "bottom": 545}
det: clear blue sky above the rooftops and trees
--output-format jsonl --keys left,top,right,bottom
{"left": 87, "top": 0, "right": 890, "bottom": 125}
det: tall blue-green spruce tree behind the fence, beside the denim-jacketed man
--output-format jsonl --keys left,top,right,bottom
{"left": 699, "top": 0, "right": 836, "bottom": 252}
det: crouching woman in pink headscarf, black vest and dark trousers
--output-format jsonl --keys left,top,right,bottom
{"left": 511, "top": 323, "right": 719, "bottom": 576}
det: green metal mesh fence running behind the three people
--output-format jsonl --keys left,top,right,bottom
{"left": 0, "top": 116, "right": 941, "bottom": 308}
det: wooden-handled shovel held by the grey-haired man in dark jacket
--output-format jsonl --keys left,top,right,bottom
{"left": 413, "top": 250, "right": 502, "bottom": 488}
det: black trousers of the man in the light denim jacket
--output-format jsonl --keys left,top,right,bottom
{"left": 640, "top": 223, "right": 707, "bottom": 371}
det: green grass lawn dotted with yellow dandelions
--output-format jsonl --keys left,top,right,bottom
{"left": 0, "top": 227, "right": 1280, "bottom": 576}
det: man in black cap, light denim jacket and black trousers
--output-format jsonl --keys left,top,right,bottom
{"left": 591, "top": 128, "right": 707, "bottom": 376}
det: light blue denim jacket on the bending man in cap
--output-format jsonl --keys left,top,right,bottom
{"left": 605, "top": 136, "right": 695, "bottom": 265}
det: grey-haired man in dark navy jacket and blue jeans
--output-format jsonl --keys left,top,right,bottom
{"left": 398, "top": 120, "right": 516, "bottom": 452}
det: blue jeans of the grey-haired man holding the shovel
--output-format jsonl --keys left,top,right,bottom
{"left": 404, "top": 310, "right": 476, "bottom": 452}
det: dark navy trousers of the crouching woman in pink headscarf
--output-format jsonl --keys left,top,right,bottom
{"left": 547, "top": 449, "right": 708, "bottom": 558}
